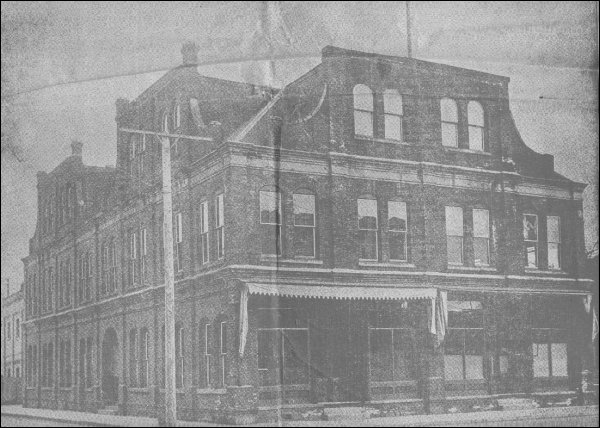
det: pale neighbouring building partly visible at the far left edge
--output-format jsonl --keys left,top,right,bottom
{"left": 2, "top": 286, "right": 25, "bottom": 378}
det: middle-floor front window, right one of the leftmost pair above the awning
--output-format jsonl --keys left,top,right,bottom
{"left": 293, "top": 193, "right": 316, "bottom": 257}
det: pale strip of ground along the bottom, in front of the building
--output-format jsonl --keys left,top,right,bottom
{"left": 2, "top": 405, "right": 598, "bottom": 427}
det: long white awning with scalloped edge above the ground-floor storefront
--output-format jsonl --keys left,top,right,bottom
{"left": 246, "top": 283, "right": 437, "bottom": 300}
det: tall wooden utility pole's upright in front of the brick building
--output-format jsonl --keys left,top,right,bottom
{"left": 160, "top": 137, "right": 177, "bottom": 427}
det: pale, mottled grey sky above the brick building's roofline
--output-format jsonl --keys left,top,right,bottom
{"left": 1, "top": 2, "right": 598, "bottom": 294}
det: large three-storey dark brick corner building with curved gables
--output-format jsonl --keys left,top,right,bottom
{"left": 23, "top": 44, "right": 593, "bottom": 422}
